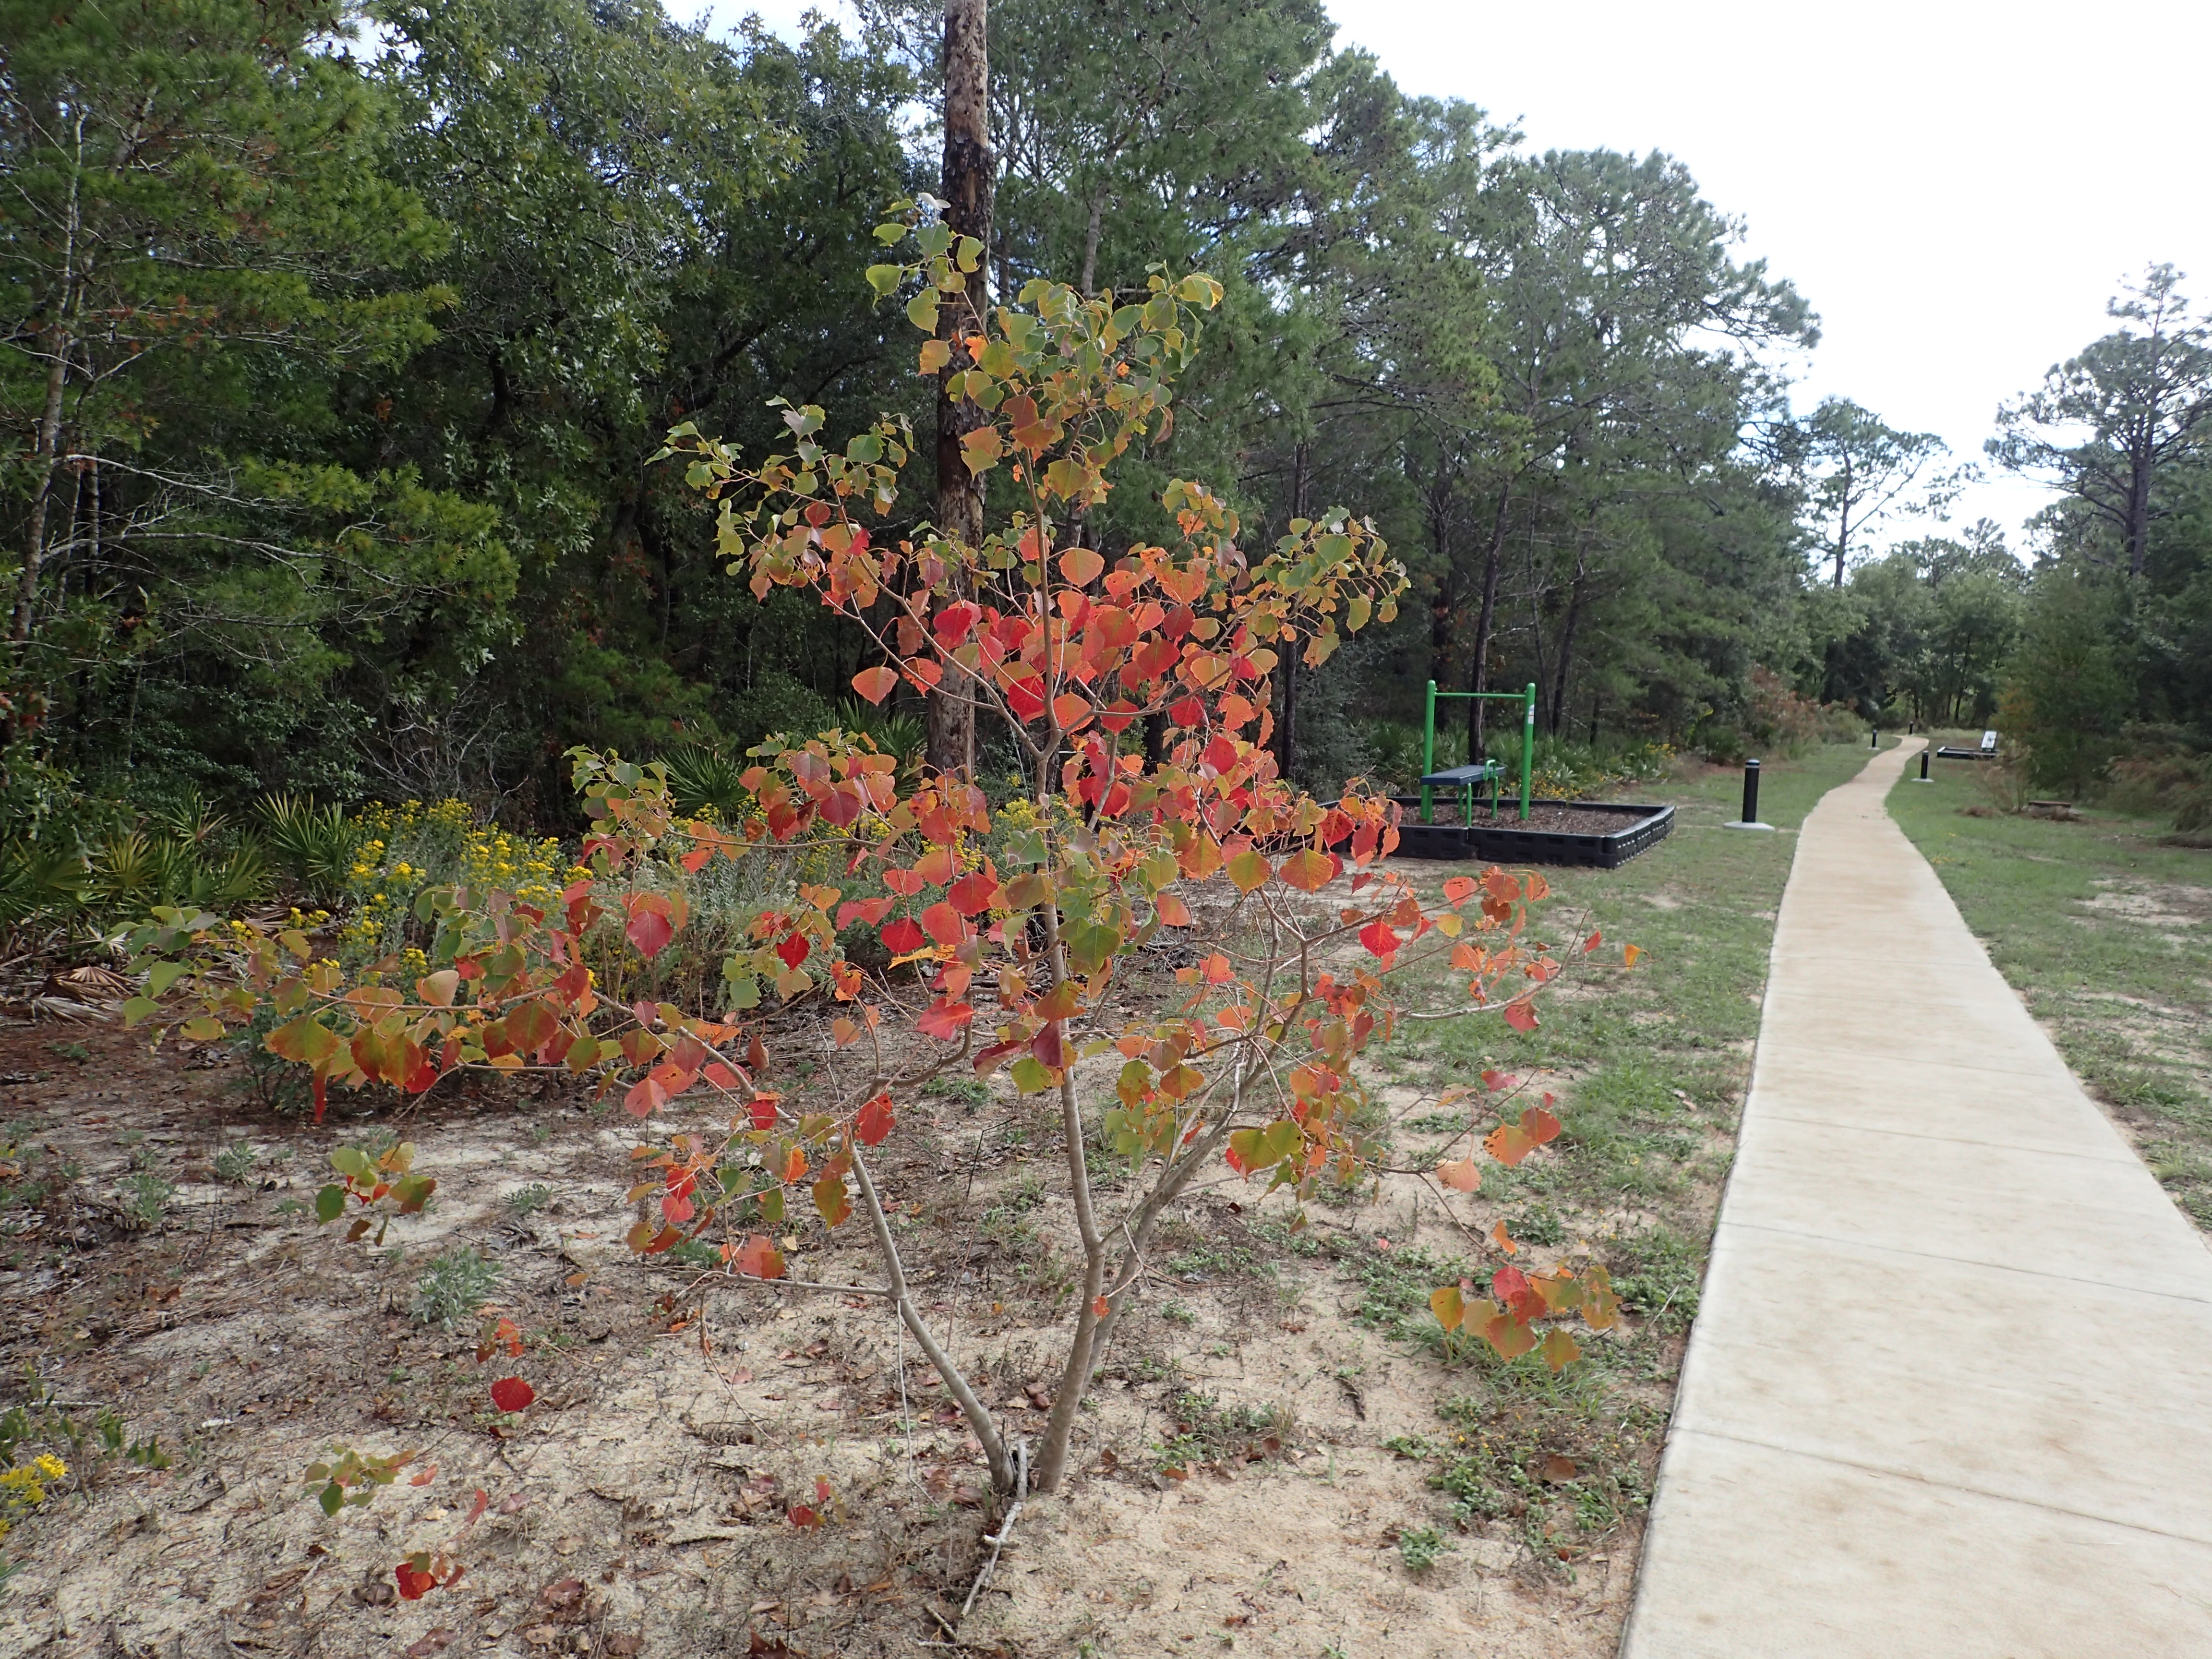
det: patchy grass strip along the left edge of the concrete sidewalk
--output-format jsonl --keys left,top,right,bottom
{"left": 1336, "top": 745, "right": 1869, "bottom": 1562}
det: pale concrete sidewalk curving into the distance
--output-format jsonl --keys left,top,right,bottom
{"left": 1622, "top": 743, "right": 2212, "bottom": 1659}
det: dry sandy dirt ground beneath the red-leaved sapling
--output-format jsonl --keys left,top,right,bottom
{"left": 0, "top": 942, "right": 1672, "bottom": 1659}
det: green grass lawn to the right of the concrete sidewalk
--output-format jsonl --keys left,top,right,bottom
{"left": 1889, "top": 761, "right": 2212, "bottom": 1230}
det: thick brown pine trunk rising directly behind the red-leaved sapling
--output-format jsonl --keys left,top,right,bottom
{"left": 929, "top": 0, "right": 996, "bottom": 776}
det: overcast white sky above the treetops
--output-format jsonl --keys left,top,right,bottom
{"left": 716, "top": 0, "right": 2212, "bottom": 559}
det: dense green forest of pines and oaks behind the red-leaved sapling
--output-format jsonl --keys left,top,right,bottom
{"left": 0, "top": 0, "right": 2212, "bottom": 847}
